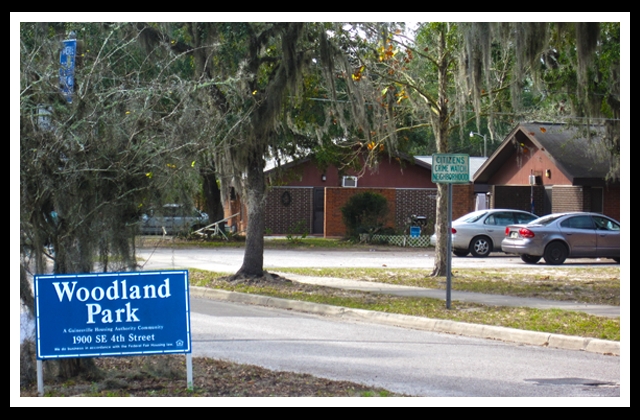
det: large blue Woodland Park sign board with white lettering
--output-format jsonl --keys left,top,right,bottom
{"left": 34, "top": 271, "right": 191, "bottom": 360}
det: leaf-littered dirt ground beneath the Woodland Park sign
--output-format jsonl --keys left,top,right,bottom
{"left": 20, "top": 356, "right": 399, "bottom": 397}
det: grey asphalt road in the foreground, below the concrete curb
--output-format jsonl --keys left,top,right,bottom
{"left": 191, "top": 298, "right": 620, "bottom": 398}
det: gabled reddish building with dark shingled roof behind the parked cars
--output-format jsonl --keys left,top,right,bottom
{"left": 473, "top": 122, "right": 620, "bottom": 220}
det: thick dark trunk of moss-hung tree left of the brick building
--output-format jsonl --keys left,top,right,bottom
{"left": 236, "top": 153, "right": 267, "bottom": 277}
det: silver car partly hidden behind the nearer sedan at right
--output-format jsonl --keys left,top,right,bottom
{"left": 431, "top": 209, "right": 538, "bottom": 257}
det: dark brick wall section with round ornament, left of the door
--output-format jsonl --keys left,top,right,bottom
{"left": 265, "top": 187, "right": 313, "bottom": 234}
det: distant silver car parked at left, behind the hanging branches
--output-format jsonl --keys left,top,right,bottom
{"left": 140, "top": 204, "right": 209, "bottom": 235}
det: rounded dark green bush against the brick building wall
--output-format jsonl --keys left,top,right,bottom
{"left": 342, "top": 192, "right": 389, "bottom": 239}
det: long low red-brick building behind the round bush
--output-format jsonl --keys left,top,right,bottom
{"left": 225, "top": 156, "right": 484, "bottom": 237}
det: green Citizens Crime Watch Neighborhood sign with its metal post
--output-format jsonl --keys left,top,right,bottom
{"left": 431, "top": 154, "right": 469, "bottom": 309}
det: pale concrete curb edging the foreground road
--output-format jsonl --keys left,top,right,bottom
{"left": 189, "top": 286, "right": 620, "bottom": 356}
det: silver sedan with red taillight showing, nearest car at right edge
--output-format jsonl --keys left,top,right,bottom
{"left": 502, "top": 212, "right": 620, "bottom": 265}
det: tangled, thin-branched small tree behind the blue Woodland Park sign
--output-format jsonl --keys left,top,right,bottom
{"left": 20, "top": 22, "right": 202, "bottom": 379}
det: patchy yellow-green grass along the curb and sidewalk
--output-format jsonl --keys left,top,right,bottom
{"left": 189, "top": 269, "right": 620, "bottom": 341}
